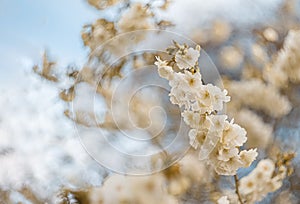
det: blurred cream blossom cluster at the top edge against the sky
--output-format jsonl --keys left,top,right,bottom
{"left": 81, "top": 0, "right": 172, "bottom": 54}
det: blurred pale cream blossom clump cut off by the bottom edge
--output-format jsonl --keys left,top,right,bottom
{"left": 89, "top": 174, "right": 178, "bottom": 204}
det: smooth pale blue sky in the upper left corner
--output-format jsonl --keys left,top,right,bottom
{"left": 0, "top": 0, "right": 101, "bottom": 87}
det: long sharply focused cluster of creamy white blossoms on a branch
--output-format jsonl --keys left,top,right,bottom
{"left": 155, "top": 43, "right": 257, "bottom": 175}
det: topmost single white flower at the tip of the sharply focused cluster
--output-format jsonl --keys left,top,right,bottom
{"left": 175, "top": 48, "right": 200, "bottom": 69}
